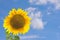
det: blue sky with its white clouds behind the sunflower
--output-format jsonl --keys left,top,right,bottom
{"left": 0, "top": 0, "right": 60, "bottom": 40}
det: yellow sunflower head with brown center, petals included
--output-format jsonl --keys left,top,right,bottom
{"left": 3, "top": 8, "right": 31, "bottom": 35}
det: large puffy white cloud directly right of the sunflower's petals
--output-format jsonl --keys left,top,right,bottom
{"left": 26, "top": 7, "right": 44, "bottom": 29}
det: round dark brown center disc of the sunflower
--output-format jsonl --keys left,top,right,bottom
{"left": 10, "top": 14, "right": 25, "bottom": 29}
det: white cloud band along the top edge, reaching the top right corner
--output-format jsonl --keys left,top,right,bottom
{"left": 29, "top": 0, "right": 60, "bottom": 9}
